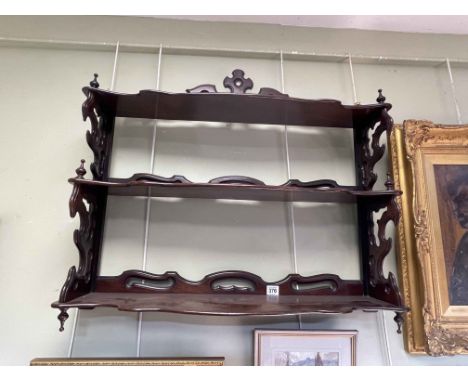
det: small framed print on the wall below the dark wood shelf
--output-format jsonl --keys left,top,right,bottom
{"left": 254, "top": 330, "right": 357, "bottom": 366}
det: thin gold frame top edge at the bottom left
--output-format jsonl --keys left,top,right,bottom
{"left": 30, "top": 357, "right": 224, "bottom": 366}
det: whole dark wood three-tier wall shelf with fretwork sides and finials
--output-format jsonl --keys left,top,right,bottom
{"left": 52, "top": 69, "right": 407, "bottom": 332}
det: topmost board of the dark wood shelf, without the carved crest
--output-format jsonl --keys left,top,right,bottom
{"left": 83, "top": 87, "right": 392, "bottom": 128}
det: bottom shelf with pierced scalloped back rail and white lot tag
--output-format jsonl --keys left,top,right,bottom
{"left": 52, "top": 270, "right": 407, "bottom": 330}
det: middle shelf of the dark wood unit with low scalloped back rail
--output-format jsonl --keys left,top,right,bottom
{"left": 69, "top": 174, "right": 401, "bottom": 203}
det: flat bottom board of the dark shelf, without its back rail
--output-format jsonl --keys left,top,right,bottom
{"left": 52, "top": 292, "right": 407, "bottom": 316}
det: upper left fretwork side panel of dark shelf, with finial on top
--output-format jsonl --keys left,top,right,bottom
{"left": 81, "top": 74, "right": 114, "bottom": 180}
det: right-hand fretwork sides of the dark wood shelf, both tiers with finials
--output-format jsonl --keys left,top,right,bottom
{"left": 354, "top": 89, "right": 403, "bottom": 333}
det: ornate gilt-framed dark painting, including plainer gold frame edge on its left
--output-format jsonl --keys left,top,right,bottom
{"left": 391, "top": 120, "right": 468, "bottom": 355}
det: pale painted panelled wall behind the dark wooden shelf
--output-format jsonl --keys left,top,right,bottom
{"left": 0, "top": 17, "right": 468, "bottom": 365}
